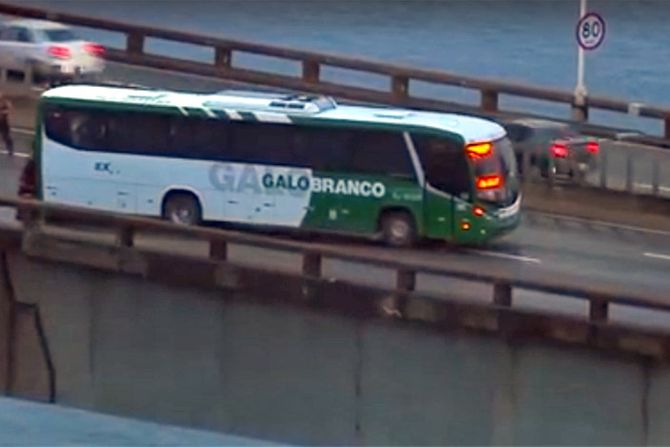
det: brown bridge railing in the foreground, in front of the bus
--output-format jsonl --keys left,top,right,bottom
{"left": 0, "top": 197, "right": 670, "bottom": 356}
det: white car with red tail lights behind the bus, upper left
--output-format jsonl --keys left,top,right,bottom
{"left": 0, "top": 20, "right": 105, "bottom": 79}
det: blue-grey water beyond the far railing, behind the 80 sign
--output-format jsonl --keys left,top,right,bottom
{"left": 14, "top": 0, "right": 670, "bottom": 133}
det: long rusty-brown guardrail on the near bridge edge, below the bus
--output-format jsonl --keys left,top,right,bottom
{"left": 0, "top": 197, "right": 670, "bottom": 355}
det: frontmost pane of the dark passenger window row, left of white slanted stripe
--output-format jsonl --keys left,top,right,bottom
{"left": 352, "top": 130, "right": 415, "bottom": 179}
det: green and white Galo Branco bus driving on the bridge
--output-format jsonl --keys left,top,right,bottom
{"left": 24, "top": 84, "right": 521, "bottom": 246}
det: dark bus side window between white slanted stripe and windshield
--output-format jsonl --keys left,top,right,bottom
{"left": 412, "top": 135, "right": 472, "bottom": 197}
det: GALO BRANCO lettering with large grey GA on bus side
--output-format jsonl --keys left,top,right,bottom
{"left": 209, "top": 163, "right": 386, "bottom": 198}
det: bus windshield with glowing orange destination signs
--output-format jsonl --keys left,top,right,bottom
{"left": 467, "top": 138, "right": 519, "bottom": 206}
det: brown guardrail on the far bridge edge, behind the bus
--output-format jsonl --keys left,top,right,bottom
{"left": 0, "top": 3, "right": 670, "bottom": 147}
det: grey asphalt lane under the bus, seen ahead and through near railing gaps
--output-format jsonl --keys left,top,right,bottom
{"left": 0, "top": 143, "right": 670, "bottom": 327}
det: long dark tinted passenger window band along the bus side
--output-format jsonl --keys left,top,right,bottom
{"left": 45, "top": 107, "right": 414, "bottom": 177}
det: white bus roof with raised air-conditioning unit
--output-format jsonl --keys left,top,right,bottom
{"left": 42, "top": 85, "right": 505, "bottom": 143}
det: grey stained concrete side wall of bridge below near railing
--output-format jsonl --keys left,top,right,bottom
{"left": 3, "top": 252, "right": 670, "bottom": 445}
